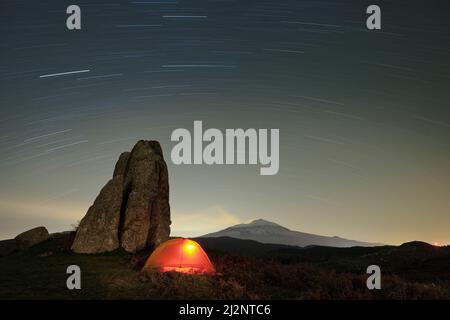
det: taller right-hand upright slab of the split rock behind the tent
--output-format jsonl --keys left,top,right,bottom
{"left": 121, "top": 141, "right": 170, "bottom": 252}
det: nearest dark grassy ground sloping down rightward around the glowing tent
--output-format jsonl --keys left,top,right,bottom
{"left": 0, "top": 238, "right": 450, "bottom": 299}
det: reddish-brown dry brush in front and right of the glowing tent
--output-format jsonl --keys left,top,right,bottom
{"left": 138, "top": 255, "right": 450, "bottom": 299}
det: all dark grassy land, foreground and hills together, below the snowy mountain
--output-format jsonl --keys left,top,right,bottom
{"left": 0, "top": 232, "right": 450, "bottom": 299}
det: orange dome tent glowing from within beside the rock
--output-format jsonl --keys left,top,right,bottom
{"left": 144, "top": 238, "right": 214, "bottom": 274}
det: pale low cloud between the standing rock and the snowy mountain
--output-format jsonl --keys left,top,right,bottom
{"left": 171, "top": 206, "right": 241, "bottom": 237}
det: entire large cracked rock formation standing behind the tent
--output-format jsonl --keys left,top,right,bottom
{"left": 72, "top": 140, "right": 170, "bottom": 253}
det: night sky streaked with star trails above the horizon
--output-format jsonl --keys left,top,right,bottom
{"left": 0, "top": 0, "right": 450, "bottom": 244}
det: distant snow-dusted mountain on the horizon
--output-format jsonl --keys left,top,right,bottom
{"left": 202, "top": 219, "right": 381, "bottom": 248}
